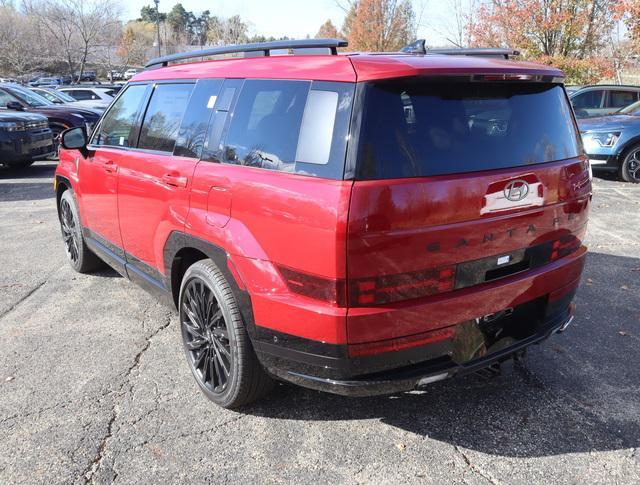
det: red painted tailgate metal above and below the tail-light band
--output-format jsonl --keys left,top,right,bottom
{"left": 347, "top": 159, "right": 591, "bottom": 343}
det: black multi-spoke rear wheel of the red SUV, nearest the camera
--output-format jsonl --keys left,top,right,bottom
{"left": 179, "top": 260, "right": 273, "bottom": 409}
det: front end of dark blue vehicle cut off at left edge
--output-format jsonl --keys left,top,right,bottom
{"left": 0, "top": 112, "right": 53, "bottom": 168}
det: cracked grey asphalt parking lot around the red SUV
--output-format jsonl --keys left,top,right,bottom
{"left": 0, "top": 162, "right": 640, "bottom": 484}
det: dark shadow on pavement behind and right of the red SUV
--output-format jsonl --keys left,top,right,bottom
{"left": 242, "top": 253, "right": 640, "bottom": 457}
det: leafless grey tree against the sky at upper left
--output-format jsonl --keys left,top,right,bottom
{"left": 24, "top": 0, "right": 120, "bottom": 80}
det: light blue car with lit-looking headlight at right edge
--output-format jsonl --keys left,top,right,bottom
{"left": 578, "top": 101, "right": 640, "bottom": 184}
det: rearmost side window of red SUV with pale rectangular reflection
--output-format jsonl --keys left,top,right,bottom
{"left": 214, "top": 80, "right": 355, "bottom": 179}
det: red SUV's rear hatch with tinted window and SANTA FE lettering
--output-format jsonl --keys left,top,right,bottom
{"left": 347, "top": 77, "right": 591, "bottom": 343}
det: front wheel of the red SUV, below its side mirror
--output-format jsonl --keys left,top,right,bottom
{"left": 58, "top": 189, "right": 103, "bottom": 273}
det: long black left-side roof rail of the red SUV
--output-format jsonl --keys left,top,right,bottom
{"left": 144, "top": 39, "right": 348, "bottom": 68}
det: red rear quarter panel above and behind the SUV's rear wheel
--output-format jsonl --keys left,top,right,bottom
{"left": 187, "top": 162, "right": 352, "bottom": 343}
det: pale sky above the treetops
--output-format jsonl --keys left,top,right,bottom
{"left": 125, "top": 0, "right": 451, "bottom": 45}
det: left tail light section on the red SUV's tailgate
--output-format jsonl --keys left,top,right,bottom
{"left": 349, "top": 266, "right": 456, "bottom": 306}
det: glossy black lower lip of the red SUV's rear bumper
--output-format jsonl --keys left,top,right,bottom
{"left": 262, "top": 306, "right": 573, "bottom": 397}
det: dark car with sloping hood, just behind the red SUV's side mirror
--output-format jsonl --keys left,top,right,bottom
{"left": 0, "top": 83, "right": 101, "bottom": 156}
